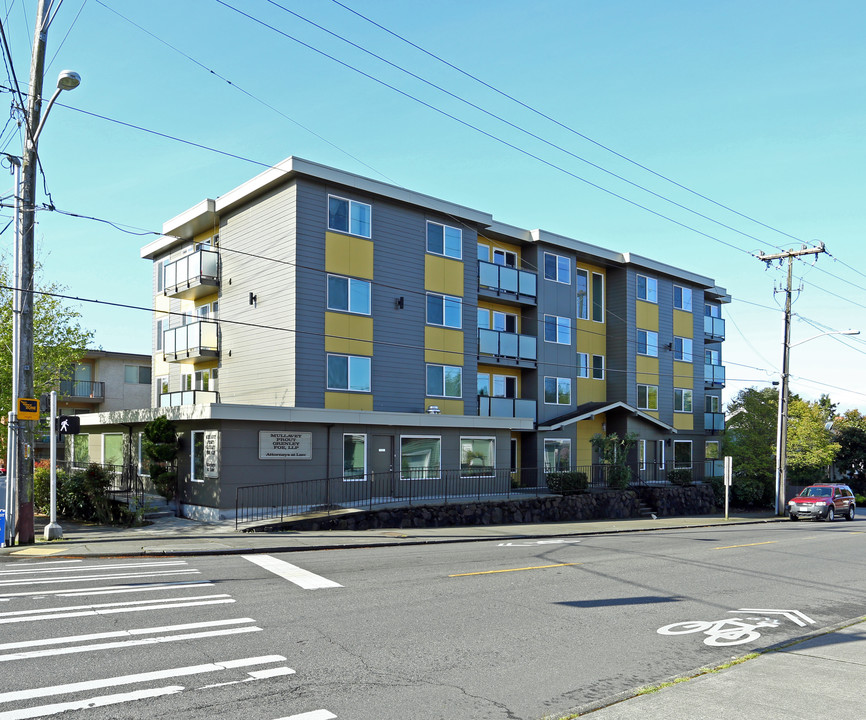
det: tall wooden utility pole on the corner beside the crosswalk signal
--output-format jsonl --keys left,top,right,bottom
{"left": 14, "top": 0, "right": 50, "bottom": 545}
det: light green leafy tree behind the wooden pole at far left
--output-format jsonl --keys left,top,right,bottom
{"left": 0, "top": 261, "right": 93, "bottom": 457}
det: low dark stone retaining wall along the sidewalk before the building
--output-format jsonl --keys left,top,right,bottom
{"left": 257, "top": 485, "right": 715, "bottom": 531}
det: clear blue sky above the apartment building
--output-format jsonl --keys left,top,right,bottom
{"left": 0, "top": 0, "right": 866, "bottom": 408}
